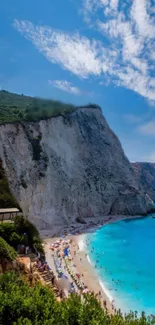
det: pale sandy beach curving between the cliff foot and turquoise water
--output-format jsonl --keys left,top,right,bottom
{"left": 42, "top": 216, "right": 149, "bottom": 313}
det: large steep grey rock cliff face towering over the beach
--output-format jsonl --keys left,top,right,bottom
{"left": 0, "top": 108, "right": 151, "bottom": 228}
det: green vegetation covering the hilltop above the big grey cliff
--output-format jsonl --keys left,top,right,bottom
{"left": 0, "top": 90, "right": 76, "bottom": 124}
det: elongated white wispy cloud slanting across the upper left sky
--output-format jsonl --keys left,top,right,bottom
{"left": 14, "top": 20, "right": 102, "bottom": 78}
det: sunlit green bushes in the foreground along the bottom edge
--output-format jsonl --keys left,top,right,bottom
{"left": 0, "top": 272, "right": 155, "bottom": 325}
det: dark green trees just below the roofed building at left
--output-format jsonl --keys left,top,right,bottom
{"left": 0, "top": 216, "right": 44, "bottom": 258}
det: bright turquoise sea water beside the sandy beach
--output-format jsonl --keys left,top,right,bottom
{"left": 86, "top": 217, "right": 155, "bottom": 314}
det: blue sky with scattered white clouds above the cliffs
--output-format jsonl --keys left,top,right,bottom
{"left": 0, "top": 0, "right": 155, "bottom": 162}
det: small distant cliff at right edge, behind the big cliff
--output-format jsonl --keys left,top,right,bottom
{"left": 132, "top": 162, "right": 155, "bottom": 201}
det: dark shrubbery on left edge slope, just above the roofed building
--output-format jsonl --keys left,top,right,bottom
{"left": 0, "top": 160, "right": 19, "bottom": 209}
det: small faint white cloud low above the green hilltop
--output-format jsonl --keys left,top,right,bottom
{"left": 48, "top": 80, "right": 81, "bottom": 95}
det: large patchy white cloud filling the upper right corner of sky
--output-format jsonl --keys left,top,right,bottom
{"left": 82, "top": 0, "right": 155, "bottom": 101}
